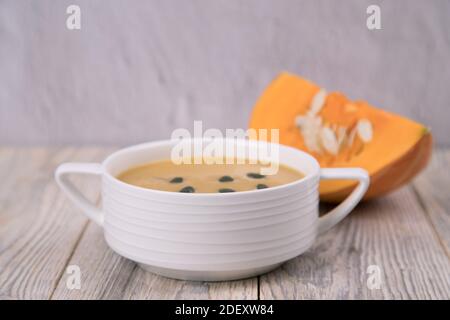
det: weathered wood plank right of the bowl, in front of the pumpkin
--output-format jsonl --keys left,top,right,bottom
{"left": 260, "top": 187, "right": 450, "bottom": 299}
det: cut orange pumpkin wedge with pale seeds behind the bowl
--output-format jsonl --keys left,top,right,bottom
{"left": 250, "top": 73, "right": 432, "bottom": 202}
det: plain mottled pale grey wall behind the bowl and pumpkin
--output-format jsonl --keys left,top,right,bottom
{"left": 0, "top": 0, "right": 450, "bottom": 146}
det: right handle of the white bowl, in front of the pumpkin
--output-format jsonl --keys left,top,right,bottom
{"left": 319, "top": 168, "right": 370, "bottom": 234}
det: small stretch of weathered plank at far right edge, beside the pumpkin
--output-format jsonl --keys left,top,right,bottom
{"left": 413, "top": 150, "right": 450, "bottom": 257}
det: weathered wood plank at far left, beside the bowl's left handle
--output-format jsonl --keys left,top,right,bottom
{"left": 0, "top": 148, "right": 107, "bottom": 299}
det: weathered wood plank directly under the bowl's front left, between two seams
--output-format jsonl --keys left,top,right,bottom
{"left": 52, "top": 218, "right": 258, "bottom": 299}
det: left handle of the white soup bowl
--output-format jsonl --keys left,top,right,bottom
{"left": 55, "top": 162, "right": 104, "bottom": 227}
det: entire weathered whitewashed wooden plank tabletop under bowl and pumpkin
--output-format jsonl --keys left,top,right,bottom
{"left": 0, "top": 148, "right": 450, "bottom": 299}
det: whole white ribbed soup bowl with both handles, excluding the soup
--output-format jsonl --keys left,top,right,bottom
{"left": 55, "top": 140, "right": 370, "bottom": 281}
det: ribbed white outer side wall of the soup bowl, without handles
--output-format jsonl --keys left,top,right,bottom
{"left": 102, "top": 174, "right": 318, "bottom": 271}
